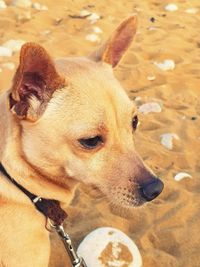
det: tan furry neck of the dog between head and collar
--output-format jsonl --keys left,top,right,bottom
{"left": 0, "top": 93, "right": 77, "bottom": 204}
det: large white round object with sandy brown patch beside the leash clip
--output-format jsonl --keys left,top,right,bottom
{"left": 77, "top": 227, "right": 142, "bottom": 267}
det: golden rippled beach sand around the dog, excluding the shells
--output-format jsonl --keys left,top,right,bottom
{"left": 0, "top": 0, "right": 200, "bottom": 267}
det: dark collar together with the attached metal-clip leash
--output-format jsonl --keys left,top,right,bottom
{"left": 0, "top": 163, "right": 87, "bottom": 267}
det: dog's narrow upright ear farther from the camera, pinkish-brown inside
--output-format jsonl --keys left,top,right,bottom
{"left": 89, "top": 16, "right": 137, "bottom": 68}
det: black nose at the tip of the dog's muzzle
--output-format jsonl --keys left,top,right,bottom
{"left": 140, "top": 179, "right": 164, "bottom": 201}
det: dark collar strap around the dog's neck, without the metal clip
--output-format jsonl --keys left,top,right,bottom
{"left": 0, "top": 163, "right": 67, "bottom": 225}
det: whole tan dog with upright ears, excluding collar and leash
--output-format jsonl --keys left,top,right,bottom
{"left": 0, "top": 16, "right": 163, "bottom": 267}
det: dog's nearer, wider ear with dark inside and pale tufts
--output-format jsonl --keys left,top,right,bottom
{"left": 9, "top": 43, "right": 65, "bottom": 121}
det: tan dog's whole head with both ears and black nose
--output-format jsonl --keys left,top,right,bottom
{"left": 9, "top": 16, "right": 163, "bottom": 206}
